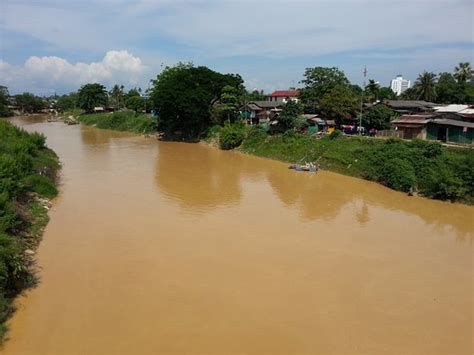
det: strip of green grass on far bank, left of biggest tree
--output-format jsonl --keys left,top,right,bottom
{"left": 79, "top": 111, "right": 156, "bottom": 134}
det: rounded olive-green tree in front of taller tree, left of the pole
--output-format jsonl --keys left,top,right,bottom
{"left": 319, "top": 85, "right": 360, "bottom": 125}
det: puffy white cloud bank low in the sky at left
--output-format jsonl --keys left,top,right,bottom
{"left": 0, "top": 50, "right": 146, "bottom": 94}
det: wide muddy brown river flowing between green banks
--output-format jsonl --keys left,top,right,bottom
{"left": 1, "top": 119, "right": 474, "bottom": 355}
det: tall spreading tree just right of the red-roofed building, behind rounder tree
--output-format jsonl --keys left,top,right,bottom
{"left": 300, "top": 67, "right": 350, "bottom": 109}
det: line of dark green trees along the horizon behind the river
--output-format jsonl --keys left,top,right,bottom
{"left": 0, "top": 63, "right": 474, "bottom": 137}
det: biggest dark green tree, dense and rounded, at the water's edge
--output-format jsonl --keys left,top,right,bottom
{"left": 150, "top": 63, "right": 243, "bottom": 139}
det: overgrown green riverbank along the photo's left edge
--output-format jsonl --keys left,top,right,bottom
{"left": 0, "top": 120, "right": 60, "bottom": 342}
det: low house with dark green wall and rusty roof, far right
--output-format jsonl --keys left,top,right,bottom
{"left": 392, "top": 112, "right": 474, "bottom": 144}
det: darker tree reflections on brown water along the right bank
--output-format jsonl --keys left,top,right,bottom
{"left": 155, "top": 143, "right": 474, "bottom": 240}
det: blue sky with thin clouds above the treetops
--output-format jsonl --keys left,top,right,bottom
{"left": 0, "top": 0, "right": 474, "bottom": 95}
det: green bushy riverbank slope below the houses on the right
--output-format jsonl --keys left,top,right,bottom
{"left": 208, "top": 125, "right": 474, "bottom": 204}
